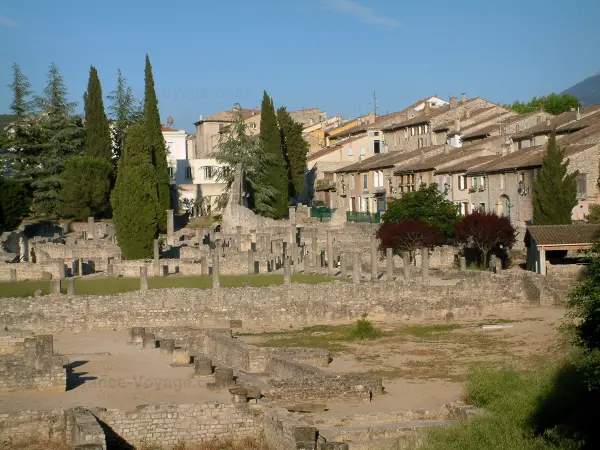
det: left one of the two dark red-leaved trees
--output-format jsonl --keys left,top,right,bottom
{"left": 377, "top": 219, "right": 444, "bottom": 261}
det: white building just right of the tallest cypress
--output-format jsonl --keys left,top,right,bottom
{"left": 162, "top": 127, "right": 226, "bottom": 214}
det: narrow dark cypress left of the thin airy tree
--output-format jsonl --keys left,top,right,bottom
{"left": 83, "top": 66, "right": 112, "bottom": 161}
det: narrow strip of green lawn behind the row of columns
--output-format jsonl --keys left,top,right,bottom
{"left": 0, "top": 274, "right": 333, "bottom": 297}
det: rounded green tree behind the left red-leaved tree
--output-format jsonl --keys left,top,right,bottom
{"left": 381, "top": 183, "right": 459, "bottom": 237}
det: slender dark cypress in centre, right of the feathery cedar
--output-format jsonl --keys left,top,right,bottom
{"left": 256, "top": 91, "right": 289, "bottom": 219}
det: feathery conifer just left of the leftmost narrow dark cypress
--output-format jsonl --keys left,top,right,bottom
{"left": 31, "top": 64, "right": 85, "bottom": 217}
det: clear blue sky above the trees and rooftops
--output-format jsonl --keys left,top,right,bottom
{"left": 0, "top": 0, "right": 600, "bottom": 132}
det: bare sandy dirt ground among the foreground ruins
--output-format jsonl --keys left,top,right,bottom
{"left": 0, "top": 307, "right": 565, "bottom": 421}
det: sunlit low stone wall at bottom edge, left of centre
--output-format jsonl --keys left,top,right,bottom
{"left": 92, "top": 402, "right": 262, "bottom": 448}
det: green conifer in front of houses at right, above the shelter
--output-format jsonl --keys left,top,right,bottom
{"left": 533, "top": 130, "right": 577, "bottom": 225}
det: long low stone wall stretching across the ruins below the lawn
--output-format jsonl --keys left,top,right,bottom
{"left": 0, "top": 272, "right": 554, "bottom": 333}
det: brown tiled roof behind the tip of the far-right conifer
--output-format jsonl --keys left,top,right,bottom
{"left": 467, "top": 143, "right": 594, "bottom": 173}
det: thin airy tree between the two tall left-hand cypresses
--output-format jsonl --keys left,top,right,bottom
{"left": 107, "top": 69, "right": 142, "bottom": 164}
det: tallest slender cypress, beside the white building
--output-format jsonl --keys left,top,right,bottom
{"left": 144, "top": 55, "right": 171, "bottom": 231}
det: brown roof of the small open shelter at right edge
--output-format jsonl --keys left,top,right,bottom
{"left": 525, "top": 223, "right": 600, "bottom": 245}
